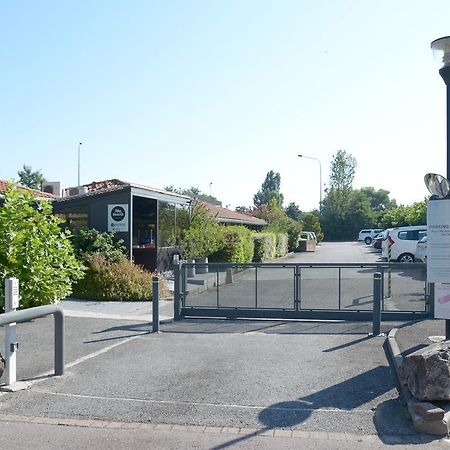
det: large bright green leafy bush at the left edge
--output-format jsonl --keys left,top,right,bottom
{"left": 0, "top": 185, "right": 83, "bottom": 308}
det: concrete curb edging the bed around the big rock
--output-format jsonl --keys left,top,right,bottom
{"left": 386, "top": 328, "right": 450, "bottom": 436}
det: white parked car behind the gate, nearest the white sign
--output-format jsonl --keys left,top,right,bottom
{"left": 381, "top": 225, "right": 427, "bottom": 263}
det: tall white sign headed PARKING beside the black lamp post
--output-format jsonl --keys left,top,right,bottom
{"left": 427, "top": 200, "right": 450, "bottom": 283}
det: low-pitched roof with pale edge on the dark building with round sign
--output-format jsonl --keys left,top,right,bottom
{"left": 58, "top": 178, "right": 191, "bottom": 203}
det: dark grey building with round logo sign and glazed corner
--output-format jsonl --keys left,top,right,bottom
{"left": 53, "top": 179, "right": 191, "bottom": 272}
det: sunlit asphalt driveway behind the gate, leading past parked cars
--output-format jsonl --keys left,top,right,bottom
{"left": 185, "top": 242, "right": 425, "bottom": 311}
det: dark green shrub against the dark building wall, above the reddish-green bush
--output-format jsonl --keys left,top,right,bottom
{"left": 72, "top": 228, "right": 126, "bottom": 262}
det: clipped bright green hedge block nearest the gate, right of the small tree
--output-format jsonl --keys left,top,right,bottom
{"left": 209, "top": 226, "right": 254, "bottom": 262}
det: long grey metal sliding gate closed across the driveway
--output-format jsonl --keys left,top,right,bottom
{"left": 174, "top": 262, "right": 433, "bottom": 321}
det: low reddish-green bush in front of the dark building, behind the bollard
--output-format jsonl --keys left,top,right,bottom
{"left": 73, "top": 253, "right": 167, "bottom": 301}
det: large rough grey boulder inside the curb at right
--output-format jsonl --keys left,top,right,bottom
{"left": 400, "top": 341, "right": 450, "bottom": 401}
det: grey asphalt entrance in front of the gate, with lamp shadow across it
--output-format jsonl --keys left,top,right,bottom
{"left": 0, "top": 244, "right": 438, "bottom": 449}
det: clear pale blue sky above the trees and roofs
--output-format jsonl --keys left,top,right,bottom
{"left": 0, "top": 0, "right": 450, "bottom": 211}
